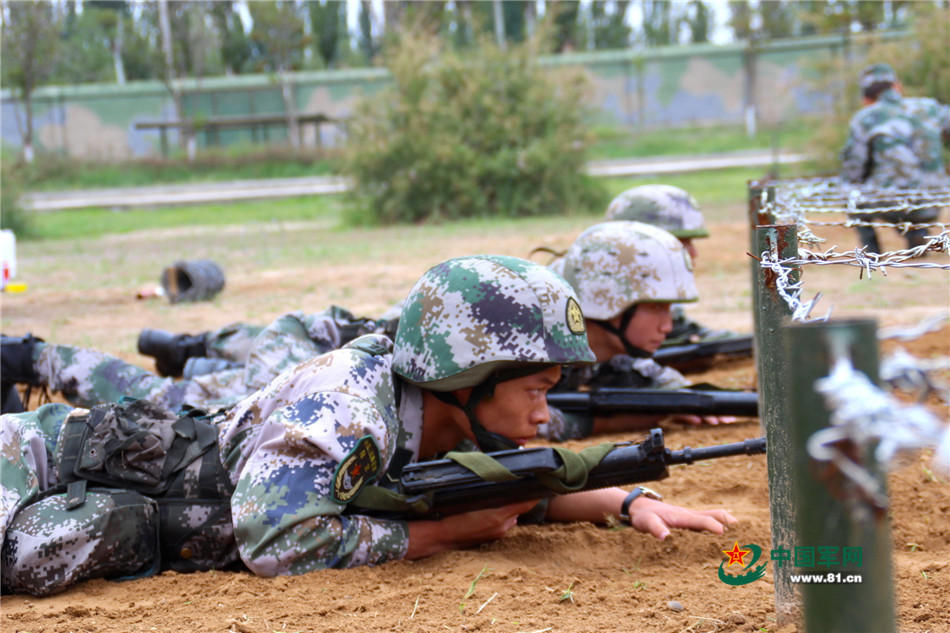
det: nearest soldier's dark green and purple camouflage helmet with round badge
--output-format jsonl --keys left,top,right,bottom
{"left": 393, "top": 255, "right": 594, "bottom": 391}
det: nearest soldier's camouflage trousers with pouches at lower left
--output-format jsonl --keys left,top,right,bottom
{"left": 0, "top": 404, "right": 238, "bottom": 596}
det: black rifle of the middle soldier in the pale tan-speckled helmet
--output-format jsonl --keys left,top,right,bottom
{"left": 548, "top": 387, "right": 759, "bottom": 417}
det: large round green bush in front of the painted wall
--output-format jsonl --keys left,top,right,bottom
{"left": 343, "top": 25, "right": 605, "bottom": 223}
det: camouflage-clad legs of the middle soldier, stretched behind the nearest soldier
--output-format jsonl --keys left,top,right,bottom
{"left": 34, "top": 306, "right": 381, "bottom": 411}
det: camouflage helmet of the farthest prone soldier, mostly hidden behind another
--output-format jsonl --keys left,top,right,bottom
{"left": 606, "top": 185, "right": 709, "bottom": 238}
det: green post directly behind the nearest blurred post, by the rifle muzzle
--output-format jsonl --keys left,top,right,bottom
{"left": 752, "top": 224, "right": 801, "bottom": 627}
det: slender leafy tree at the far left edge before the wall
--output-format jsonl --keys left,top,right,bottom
{"left": 0, "top": 2, "right": 62, "bottom": 163}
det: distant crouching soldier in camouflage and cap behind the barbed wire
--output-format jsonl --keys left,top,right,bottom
{"left": 841, "top": 64, "right": 950, "bottom": 253}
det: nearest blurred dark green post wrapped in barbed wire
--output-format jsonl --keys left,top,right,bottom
{"left": 784, "top": 319, "right": 896, "bottom": 633}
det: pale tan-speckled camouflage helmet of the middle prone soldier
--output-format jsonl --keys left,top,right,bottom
{"left": 563, "top": 221, "right": 699, "bottom": 321}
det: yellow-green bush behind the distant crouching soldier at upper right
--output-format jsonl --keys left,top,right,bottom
{"left": 809, "top": 3, "right": 950, "bottom": 172}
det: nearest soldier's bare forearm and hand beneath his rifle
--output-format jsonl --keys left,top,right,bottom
{"left": 406, "top": 501, "right": 538, "bottom": 559}
